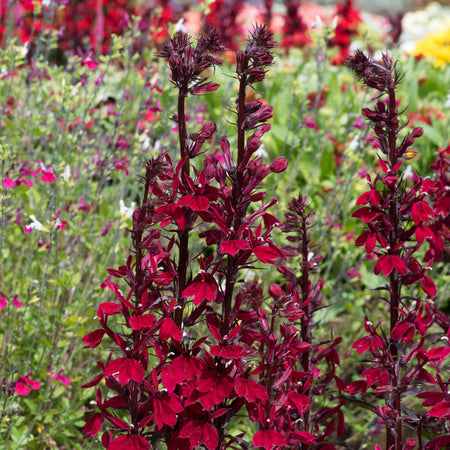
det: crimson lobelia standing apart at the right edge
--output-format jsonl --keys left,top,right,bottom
{"left": 345, "top": 51, "right": 449, "bottom": 450}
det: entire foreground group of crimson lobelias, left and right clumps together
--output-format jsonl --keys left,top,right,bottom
{"left": 78, "top": 26, "right": 450, "bottom": 450}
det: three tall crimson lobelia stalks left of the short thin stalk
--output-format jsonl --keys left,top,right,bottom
{"left": 83, "top": 26, "right": 292, "bottom": 450}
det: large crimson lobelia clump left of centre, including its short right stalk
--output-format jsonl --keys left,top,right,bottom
{"left": 83, "top": 26, "right": 344, "bottom": 450}
